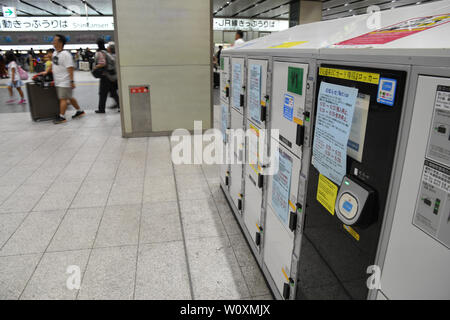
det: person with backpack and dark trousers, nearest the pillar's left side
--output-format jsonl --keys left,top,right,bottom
{"left": 92, "top": 38, "right": 119, "bottom": 114}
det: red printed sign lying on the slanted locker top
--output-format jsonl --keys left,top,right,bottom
{"left": 336, "top": 14, "right": 450, "bottom": 46}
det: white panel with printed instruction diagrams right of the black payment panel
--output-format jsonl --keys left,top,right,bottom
{"left": 381, "top": 76, "right": 450, "bottom": 300}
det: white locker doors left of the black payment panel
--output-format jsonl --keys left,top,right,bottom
{"left": 220, "top": 57, "right": 314, "bottom": 299}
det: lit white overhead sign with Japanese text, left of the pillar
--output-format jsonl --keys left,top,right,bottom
{"left": 0, "top": 17, "right": 114, "bottom": 32}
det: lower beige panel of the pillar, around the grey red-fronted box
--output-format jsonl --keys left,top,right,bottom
{"left": 121, "top": 66, "right": 211, "bottom": 133}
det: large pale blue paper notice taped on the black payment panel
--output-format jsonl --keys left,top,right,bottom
{"left": 312, "top": 82, "right": 358, "bottom": 185}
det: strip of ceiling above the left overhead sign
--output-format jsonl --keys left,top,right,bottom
{"left": 0, "top": 0, "right": 113, "bottom": 16}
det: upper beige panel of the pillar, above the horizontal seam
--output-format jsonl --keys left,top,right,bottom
{"left": 116, "top": 0, "right": 211, "bottom": 66}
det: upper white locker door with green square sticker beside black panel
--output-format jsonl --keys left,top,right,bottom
{"left": 271, "top": 61, "right": 308, "bottom": 155}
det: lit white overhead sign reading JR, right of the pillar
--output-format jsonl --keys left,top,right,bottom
{"left": 213, "top": 18, "right": 289, "bottom": 32}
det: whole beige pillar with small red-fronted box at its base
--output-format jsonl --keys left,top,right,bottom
{"left": 113, "top": 0, "right": 213, "bottom": 137}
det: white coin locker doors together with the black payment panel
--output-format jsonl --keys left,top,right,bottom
{"left": 221, "top": 52, "right": 444, "bottom": 299}
